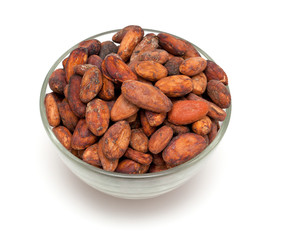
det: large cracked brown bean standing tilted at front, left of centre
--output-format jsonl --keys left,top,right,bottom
{"left": 102, "top": 121, "right": 131, "bottom": 160}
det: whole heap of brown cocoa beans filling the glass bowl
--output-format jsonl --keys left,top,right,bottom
{"left": 44, "top": 25, "right": 231, "bottom": 174}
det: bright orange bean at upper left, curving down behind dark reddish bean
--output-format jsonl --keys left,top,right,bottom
{"left": 65, "top": 47, "right": 88, "bottom": 83}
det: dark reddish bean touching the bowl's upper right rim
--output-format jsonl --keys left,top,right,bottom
{"left": 205, "top": 60, "right": 228, "bottom": 85}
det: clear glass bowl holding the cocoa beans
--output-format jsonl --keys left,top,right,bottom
{"left": 40, "top": 29, "right": 231, "bottom": 199}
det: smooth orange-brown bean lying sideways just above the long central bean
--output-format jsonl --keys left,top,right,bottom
{"left": 132, "top": 61, "right": 168, "bottom": 82}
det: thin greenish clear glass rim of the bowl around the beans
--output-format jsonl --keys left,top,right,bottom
{"left": 39, "top": 28, "right": 232, "bottom": 179}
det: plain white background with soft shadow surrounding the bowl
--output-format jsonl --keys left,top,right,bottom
{"left": 0, "top": 0, "right": 282, "bottom": 240}
